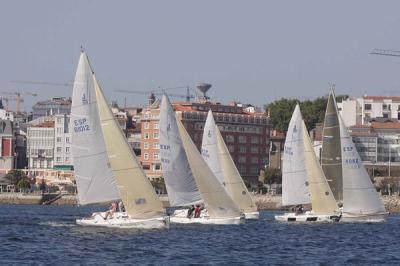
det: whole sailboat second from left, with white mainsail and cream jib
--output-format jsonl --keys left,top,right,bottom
{"left": 160, "top": 95, "right": 244, "bottom": 224}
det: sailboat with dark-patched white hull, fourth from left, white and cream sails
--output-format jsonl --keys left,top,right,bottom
{"left": 275, "top": 105, "right": 340, "bottom": 222}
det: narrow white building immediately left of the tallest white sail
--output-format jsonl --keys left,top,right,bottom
{"left": 54, "top": 114, "right": 73, "bottom": 168}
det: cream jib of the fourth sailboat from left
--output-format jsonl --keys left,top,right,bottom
{"left": 302, "top": 121, "right": 339, "bottom": 215}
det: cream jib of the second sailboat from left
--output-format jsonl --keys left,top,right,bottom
{"left": 176, "top": 116, "right": 241, "bottom": 218}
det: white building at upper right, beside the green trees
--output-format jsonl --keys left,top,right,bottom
{"left": 338, "top": 96, "right": 400, "bottom": 127}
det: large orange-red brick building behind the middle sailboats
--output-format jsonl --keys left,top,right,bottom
{"left": 140, "top": 98, "right": 271, "bottom": 184}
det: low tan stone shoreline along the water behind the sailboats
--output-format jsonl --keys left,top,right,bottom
{"left": 0, "top": 193, "right": 400, "bottom": 213}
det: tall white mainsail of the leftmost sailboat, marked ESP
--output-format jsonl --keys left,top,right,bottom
{"left": 71, "top": 52, "right": 120, "bottom": 204}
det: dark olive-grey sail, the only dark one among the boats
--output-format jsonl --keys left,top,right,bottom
{"left": 321, "top": 92, "right": 343, "bottom": 201}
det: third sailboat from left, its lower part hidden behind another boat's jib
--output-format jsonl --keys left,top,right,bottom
{"left": 201, "top": 110, "right": 259, "bottom": 219}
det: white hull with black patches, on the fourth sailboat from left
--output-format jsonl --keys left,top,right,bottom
{"left": 275, "top": 212, "right": 340, "bottom": 223}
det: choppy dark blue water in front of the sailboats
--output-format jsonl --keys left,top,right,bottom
{"left": 0, "top": 205, "right": 400, "bottom": 265}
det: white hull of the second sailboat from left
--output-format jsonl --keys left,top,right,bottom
{"left": 170, "top": 209, "right": 244, "bottom": 224}
